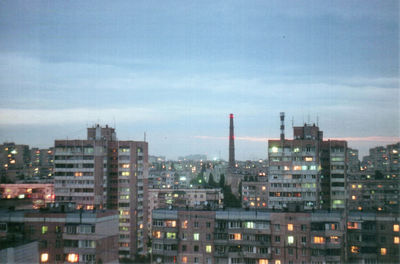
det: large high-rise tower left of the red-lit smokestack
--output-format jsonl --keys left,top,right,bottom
{"left": 54, "top": 125, "right": 148, "bottom": 258}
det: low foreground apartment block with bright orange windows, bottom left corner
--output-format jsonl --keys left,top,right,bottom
{"left": 0, "top": 208, "right": 118, "bottom": 263}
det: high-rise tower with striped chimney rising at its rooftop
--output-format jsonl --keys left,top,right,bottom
{"left": 268, "top": 114, "right": 347, "bottom": 209}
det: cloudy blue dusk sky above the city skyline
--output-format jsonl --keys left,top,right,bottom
{"left": 0, "top": 0, "right": 400, "bottom": 160}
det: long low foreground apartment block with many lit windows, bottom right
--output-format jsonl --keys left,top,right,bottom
{"left": 152, "top": 209, "right": 400, "bottom": 264}
